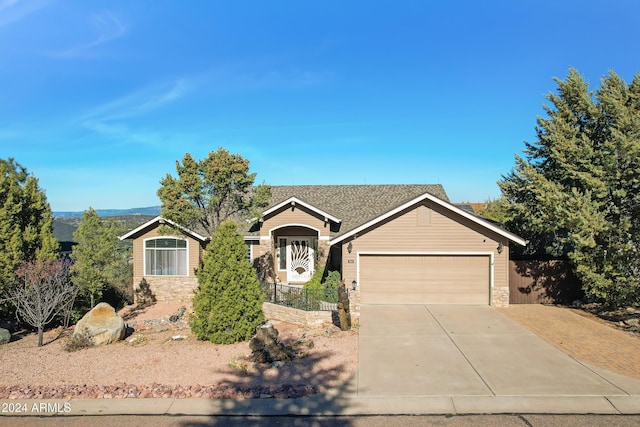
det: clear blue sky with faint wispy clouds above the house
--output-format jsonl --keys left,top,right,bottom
{"left": 0, "top": 0, "right": 640, "bottom": 211}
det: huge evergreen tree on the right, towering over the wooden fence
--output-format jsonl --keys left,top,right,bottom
{"left": 499, "top": 69, "right": 640, "bottom": 306}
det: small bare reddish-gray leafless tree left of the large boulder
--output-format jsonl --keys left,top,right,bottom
{"left": 9, "top": 259, "right": 78, "bottom": 347}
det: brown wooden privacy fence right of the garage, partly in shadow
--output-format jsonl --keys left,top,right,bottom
{"left": 509, "top": 259, "right": 583, "bottom": 304}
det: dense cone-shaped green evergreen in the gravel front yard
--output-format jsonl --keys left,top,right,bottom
{"left": 190, "top": 220, "right": 264, "bottom": 344}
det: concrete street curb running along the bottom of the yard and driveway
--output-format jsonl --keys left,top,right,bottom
{"left": 0, "top": 394, "right": 640, "bottom": 416}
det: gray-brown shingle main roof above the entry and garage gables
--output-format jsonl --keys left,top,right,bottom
{"left": 262, "top": 184, "right": 449, "bottom": 237}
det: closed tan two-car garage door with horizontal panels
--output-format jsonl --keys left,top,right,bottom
{"left": 360, "top": 255, "right": 490, "bottom": 304}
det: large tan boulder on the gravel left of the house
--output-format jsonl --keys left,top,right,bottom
{"left": 73, "top": 302, "right": 126, "bottom": 345}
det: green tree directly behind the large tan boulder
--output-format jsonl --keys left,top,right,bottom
{"left": 71, "top": 208, "right": 132, "bottom": 307}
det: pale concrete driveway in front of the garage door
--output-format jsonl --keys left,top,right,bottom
{"left": 357, "top": 305, "right": 640, "bottom": 397}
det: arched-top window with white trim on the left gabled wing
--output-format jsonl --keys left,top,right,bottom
{"left": 144, "top": 237, "right": 187, "bottom": 276}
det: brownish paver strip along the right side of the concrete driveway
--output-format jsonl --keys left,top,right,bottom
{"left": 498, "top": 304, "right": 640, "bottom": 379}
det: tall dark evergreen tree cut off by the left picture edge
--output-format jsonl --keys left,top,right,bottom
{"left": 0, "top": 159, "right": 58, "bottom": 304}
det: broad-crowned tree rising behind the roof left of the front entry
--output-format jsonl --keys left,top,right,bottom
{"left": 158, "top": 147, "right": 271, "bottom": 235}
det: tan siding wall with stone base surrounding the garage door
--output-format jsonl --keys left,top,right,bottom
{"left": 342, "top": 203, "right": 509, "bottom": 306}
